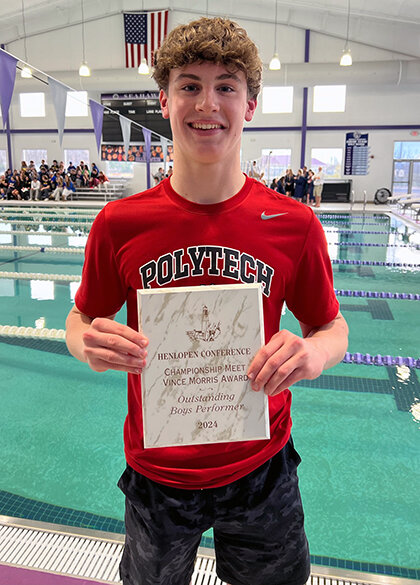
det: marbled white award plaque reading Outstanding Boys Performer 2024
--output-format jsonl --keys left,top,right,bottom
{"left": 137, "top": 284, "right": 270, "bottom": 448}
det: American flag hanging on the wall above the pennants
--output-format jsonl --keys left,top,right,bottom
{"left": 124, "top": 10, "right": 168, "bottom": 67}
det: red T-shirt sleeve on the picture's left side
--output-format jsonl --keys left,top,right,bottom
{"left": 75, "top": 208, "right": 127, "bottom": 318}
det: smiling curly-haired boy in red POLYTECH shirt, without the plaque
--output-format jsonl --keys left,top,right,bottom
{"left": 67, "top": 18, "right": 347, "bottom": 585}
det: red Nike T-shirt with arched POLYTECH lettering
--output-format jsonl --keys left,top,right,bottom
{"left": 76, "top": 177, "right": 338, "bottom": 489}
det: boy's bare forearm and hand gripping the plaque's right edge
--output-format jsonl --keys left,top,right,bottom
{"left": 248, "top": 313, "right": 348, "bottom": 396}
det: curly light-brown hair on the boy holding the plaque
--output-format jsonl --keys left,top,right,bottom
{"left": 153, "top": 17, "right": 262, "bottom": 99}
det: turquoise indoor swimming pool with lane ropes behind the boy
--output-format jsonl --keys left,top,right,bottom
{"left": 0, "top": 205, "right": 420, "bottom": 579}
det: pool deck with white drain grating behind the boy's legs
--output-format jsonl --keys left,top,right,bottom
{"left": 0, "top": 516, "right": 419, "bottom": 585}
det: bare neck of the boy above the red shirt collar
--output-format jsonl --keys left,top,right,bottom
{"left": 171, "top": 154, "right": 245, "bottom": 205}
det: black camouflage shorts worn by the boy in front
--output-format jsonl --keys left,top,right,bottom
{"left": 118, "top": 438, "right": 310, "bottom": 585}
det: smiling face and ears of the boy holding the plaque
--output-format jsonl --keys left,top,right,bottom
{"left": 160, "top": 62, "right": 257, "bottom": 164}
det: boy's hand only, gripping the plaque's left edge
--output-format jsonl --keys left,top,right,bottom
{"left": 82, "top": 317, "right": 149, "bottom": 374}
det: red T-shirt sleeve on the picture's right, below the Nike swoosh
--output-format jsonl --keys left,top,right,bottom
{"left": 286, "top": 214, "right": 339, "bottom": 327}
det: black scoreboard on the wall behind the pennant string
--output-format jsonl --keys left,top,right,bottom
{"left": 101, "top": 91, "right": 172, "bottom": 143}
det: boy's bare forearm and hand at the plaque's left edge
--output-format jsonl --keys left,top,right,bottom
{"left": 66, "top": 306, "right": 148, "bottom": 374}
